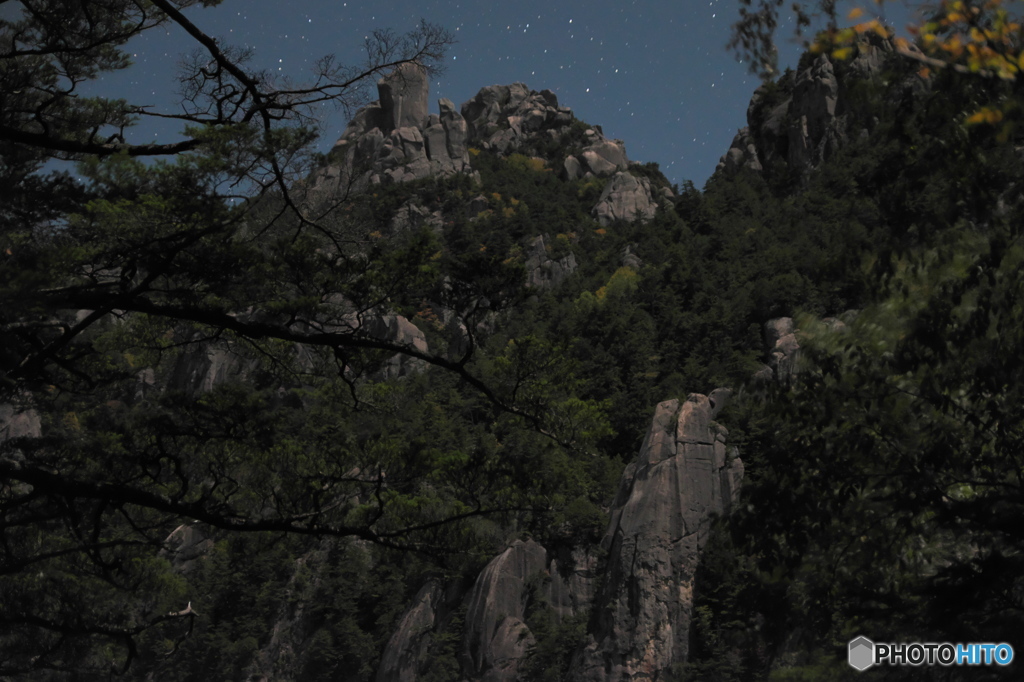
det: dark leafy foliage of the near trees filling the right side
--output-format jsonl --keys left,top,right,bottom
{"left": 716, "top": 46, "right": 1024, "bottom": 679}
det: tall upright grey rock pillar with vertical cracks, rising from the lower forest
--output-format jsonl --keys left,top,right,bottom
{"left": 577, "top": 394, "right": 743, "bottom": 682}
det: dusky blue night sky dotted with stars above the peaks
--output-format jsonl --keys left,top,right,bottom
{"left": 12, "top": 0, "right": 913, "bottom": 187}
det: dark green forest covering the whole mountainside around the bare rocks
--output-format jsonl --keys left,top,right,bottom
{"left": 0, "top": 0, "right": 1024, "bottom": 682}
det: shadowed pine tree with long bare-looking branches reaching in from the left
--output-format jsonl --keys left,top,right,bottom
{"left": 0, "top": 0, "right": 622, "bottom": 678}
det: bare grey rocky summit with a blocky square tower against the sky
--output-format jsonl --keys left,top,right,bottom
{"left": 310, "top": 67, "right": 673, "bottom": 225}
